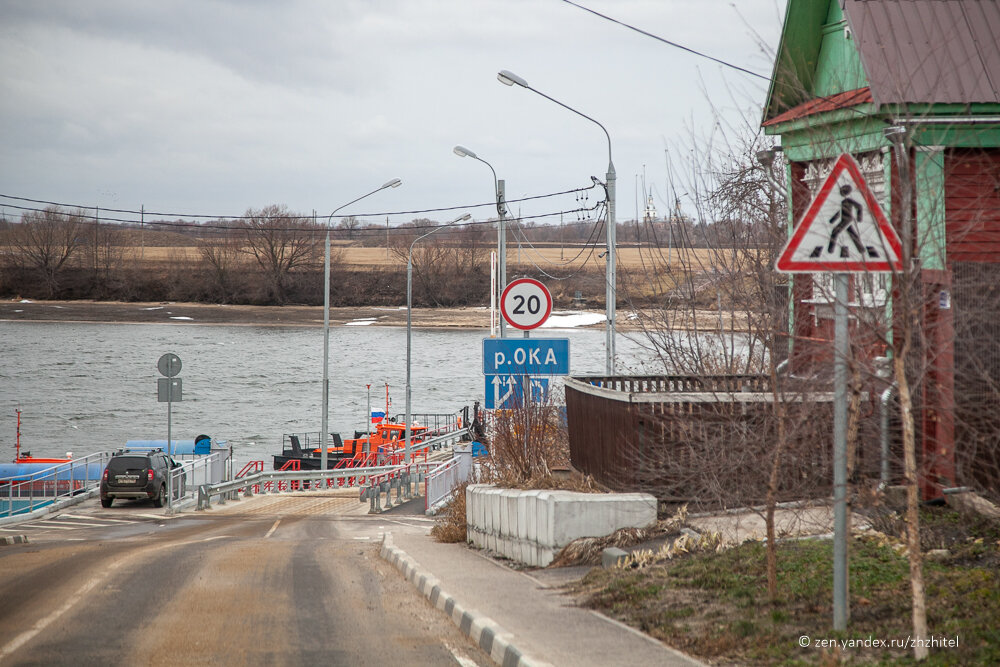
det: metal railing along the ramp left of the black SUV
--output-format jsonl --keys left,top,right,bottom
{"left": 0, "top": 452, "right": 112, "bottom": 521}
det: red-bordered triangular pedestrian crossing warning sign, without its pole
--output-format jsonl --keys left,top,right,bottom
{"left": 775, "top": 153, "right": 902, "bottom": 273}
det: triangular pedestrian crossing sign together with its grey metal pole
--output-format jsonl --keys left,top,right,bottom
{"left": 775, "top": 153, "right": 903, "bottom": 630}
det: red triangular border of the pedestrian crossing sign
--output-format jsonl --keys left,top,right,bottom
{"left": 775, "top": 153, "right": 903, "bottom": 273}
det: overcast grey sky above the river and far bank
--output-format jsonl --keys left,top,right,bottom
{"left": 0, "top": 0, "right": 785, "bottom": 223}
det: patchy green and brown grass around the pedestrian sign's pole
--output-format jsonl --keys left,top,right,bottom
{"left": 577, "top": 512, "right": 1000, "bottom": 665}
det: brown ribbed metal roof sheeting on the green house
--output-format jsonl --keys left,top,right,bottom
{"left": 841, "top": 0, "right": 1000, "bottom": 106}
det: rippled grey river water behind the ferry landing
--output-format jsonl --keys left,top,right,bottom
{"left": 0, "top": 322, "right": 656, "bottom": 467}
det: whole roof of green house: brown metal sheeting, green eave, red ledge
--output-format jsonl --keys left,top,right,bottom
{"left": 764, "top": 0, "right": 1000, "bottom": 126}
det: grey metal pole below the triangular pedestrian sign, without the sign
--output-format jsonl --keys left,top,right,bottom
{"left": 833, "top": 273, "right": 850, "bottom": 630}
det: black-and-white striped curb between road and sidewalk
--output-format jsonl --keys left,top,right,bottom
{"left": 379, "top": 532, "right": 552, "bottom": 667}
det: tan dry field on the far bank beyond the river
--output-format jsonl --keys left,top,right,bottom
{"left": 121, "top": 245, "right": 717, "bottom": 271}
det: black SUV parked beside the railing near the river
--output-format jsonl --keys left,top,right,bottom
{"left": 101, "top": 449, "right": 186, "bottom": 507}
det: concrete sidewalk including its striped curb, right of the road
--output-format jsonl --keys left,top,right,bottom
{"left": 381, "top": 524, "right": 703, "bottom": 667}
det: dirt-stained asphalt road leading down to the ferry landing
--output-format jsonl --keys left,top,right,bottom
{"left": 0, "top": 494, "right": 492, "bottom": 665}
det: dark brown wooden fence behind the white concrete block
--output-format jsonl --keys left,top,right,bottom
{"left": 566, "top": 375, "right": 878, "bottom": 508}
